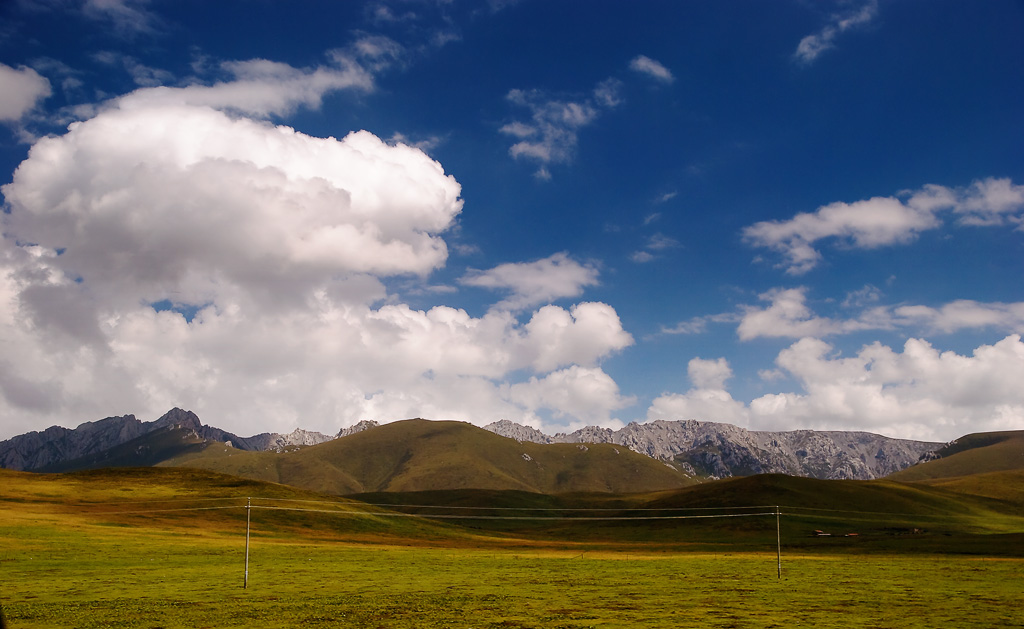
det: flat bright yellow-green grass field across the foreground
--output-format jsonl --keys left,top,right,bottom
{"left": 0, "top": 501, "right": 1024, "bottom": 629}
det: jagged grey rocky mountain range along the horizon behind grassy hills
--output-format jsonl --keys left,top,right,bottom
{"left": 0, "top": 409, "right": 943, "bottom": 483}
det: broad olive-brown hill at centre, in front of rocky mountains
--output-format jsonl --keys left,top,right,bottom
{"left": 162, "top": 420, "right": 694, "bottom": 494}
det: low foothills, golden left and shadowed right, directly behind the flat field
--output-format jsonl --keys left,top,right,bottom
{"left": 8, "top": 468, "right": 1024, "bottom": 554}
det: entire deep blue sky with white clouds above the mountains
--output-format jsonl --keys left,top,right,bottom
{"left": 0, "top": 0, "right": 1024, "bottom": 441}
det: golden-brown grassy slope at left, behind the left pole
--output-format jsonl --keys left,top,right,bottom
{"left": 0, "top": 467, "right": 495, "bottom": 544}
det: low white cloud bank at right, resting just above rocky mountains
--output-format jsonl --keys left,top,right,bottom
{"left": 647, "top": 335, "right": 1024, "bottom": 441}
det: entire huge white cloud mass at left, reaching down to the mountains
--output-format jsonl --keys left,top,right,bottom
{"left": 0, "top": 90, "right": 633, "bottom": 434}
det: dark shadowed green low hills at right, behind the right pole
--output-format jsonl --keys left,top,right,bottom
{"left": 351, "top": 474, "right": 1024, "bottom": 555}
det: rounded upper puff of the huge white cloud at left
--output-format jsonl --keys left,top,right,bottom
{"left": 3, "top": 106, "right": 462, "bottom": 311}
